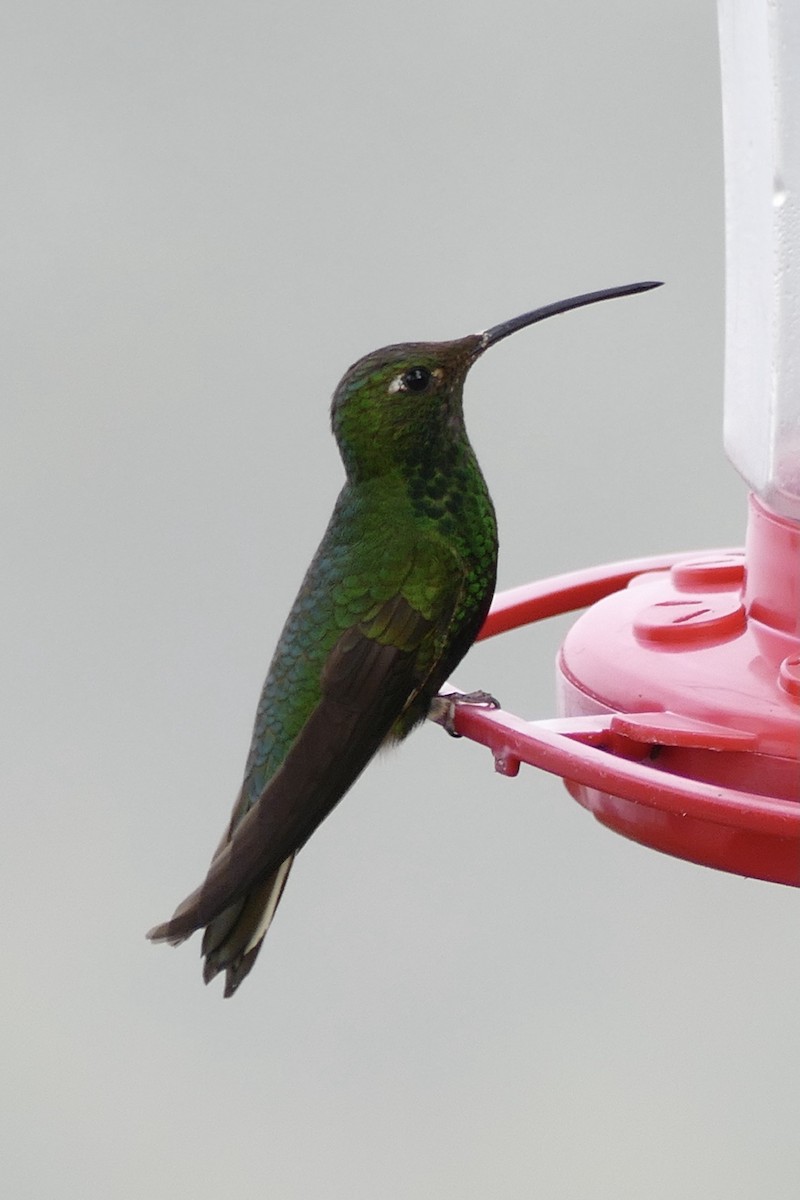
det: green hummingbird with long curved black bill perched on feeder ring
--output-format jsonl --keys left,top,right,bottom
{"left": 148, "top": 282, "right": 660, "bottom": 996}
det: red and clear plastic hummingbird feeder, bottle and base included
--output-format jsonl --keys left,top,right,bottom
{"left": 443, "top": 0, "right": 800, "bottom": 887}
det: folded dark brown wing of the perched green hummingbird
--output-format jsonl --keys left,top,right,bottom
{"left": 148, "top": 596, "right": 435, "bottom": 942}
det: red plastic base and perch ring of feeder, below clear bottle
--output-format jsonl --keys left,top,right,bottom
{"left": 448, "top": 498, "right": 800, "bottom": 887}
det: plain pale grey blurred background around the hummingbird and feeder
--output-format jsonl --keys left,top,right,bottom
{"left": 0, "top": 0, "right": 800, "bottom": 1200}
